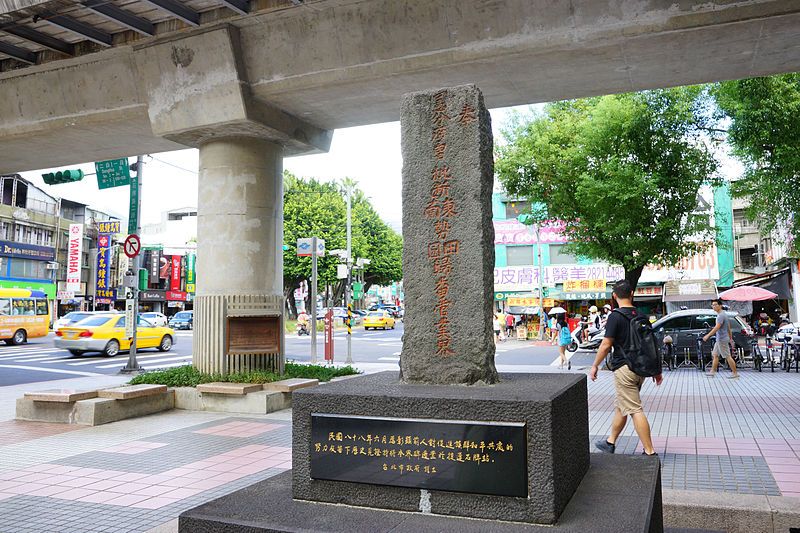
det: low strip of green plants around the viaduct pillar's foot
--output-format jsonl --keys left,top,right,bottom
{"left": 129, "top": 363, "right": 360, "bottom": 387}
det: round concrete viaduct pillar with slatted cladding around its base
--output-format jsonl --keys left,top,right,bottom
{"left": 192, "top": 137, "right": 283, "bottom": 374}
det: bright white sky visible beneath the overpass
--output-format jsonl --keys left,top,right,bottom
{"left": 22, "top": 105, "right": 741, "bottom": 233}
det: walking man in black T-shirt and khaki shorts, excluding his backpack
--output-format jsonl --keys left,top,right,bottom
{"left": 589, "top": 280, "right": 662, "bottom": 455}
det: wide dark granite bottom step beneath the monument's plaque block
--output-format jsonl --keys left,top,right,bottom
{"left": 179, "top": 454, "right": 663, "bottom": 533}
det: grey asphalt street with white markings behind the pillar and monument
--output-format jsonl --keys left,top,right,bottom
{"left": 0, "top": 322, "right": 580, "bottom": 386}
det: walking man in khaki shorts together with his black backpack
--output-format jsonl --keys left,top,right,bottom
{"left": 589, "top": 280, "right": 662, "bottom": 455}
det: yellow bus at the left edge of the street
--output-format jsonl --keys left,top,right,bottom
{"left": 0, "top": 289, "right": 50, "bottom": 345}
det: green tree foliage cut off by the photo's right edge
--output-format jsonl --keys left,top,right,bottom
{"left": 713, "top": 73, "right": 800, "bottom": 253}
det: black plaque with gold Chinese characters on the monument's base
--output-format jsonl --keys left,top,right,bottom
{"left": 311, "top": 413, "right": 528, "bottom": 498}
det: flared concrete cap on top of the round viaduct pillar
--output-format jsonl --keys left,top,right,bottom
{"left": 136, "top": 25, "right": 332, "bottom": 155}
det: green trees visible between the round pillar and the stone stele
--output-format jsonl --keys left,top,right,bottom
{"left": 283, "top": 172, "right": 403, "bottom": 316}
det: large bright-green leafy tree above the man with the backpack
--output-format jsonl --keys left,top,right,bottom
{"left": 495, "top": 87, "right": 717, "bottom": 287}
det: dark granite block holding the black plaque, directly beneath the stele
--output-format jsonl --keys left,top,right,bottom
{"left": 292, "top": 372, "right": 589, "bottom": 524}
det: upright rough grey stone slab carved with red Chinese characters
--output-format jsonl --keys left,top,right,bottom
{"left": 400, "top": 86, "right": 497, "bottom": 384}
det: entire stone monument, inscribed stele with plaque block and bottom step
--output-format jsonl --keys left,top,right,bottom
{"left": 180, "top": 85, "right": 661, "bottom": 533}
